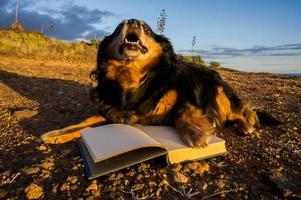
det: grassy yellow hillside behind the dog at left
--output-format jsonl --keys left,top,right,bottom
{"left": 0, "top": 29, "right": 97, "bottom": 61}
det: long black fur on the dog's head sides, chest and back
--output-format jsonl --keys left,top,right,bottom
{"left": 91, "top": 20, "right": 242, "bottom": 125}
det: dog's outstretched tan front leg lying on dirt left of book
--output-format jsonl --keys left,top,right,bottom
{"left": 41, "top": 115, "right": 106, "bottom": 144}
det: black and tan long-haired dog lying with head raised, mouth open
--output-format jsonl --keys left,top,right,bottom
{"left": 42, "top": 19, "right": 275, "bottom": 147}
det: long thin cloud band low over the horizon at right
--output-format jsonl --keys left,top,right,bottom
{"left": 179, "top": 43, "right": 301, "bottom": 57}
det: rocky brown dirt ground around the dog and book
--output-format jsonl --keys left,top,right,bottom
{"left": 0, "top": 57, "right": 301, "bottom": 200}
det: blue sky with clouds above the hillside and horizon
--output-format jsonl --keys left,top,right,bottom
{"left": 0, "top": 0, "right": 301, "bottom": 73}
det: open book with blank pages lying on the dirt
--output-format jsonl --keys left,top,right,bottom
{"left": 79, "top": 124, "right": 226, "bottom": 179}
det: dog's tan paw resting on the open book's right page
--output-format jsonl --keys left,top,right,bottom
{"left": 182, "top": 125, "right": 213, "bottom": 148}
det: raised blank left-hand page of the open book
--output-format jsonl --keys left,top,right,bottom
{"left": 81, "top": 124, "right": 163, "bottom": 162}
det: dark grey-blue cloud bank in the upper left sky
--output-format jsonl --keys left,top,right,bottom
{"left": 0, "top": 0, "right": 115, "bottom": 40}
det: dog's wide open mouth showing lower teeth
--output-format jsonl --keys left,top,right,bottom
{"left": 119, "top": 32, "right": 148, "bottom": 54}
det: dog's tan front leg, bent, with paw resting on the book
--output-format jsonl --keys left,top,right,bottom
{"left": 175, "top": 104, "right": 213, "bottom": 147}
